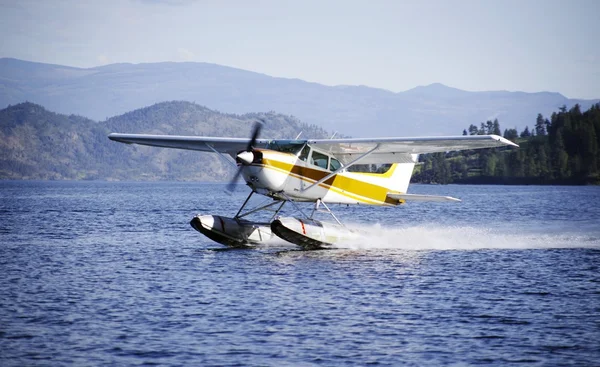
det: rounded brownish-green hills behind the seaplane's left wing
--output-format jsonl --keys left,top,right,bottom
{"left": 0, "top": 102, "right": 328, "bottom": 181}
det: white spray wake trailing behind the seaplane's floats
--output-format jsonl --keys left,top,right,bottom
{"left": 336, "top": 224, "right": 600, "bottom": 250}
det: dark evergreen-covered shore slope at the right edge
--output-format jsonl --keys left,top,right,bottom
{"left": 413, "top": 104, "right": 600, "bottom": 185}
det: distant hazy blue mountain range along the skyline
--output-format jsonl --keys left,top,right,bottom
{"left": 0, "top": 58, "right": 599, "bottom": 137}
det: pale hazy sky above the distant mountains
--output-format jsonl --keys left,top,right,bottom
{"left": 0, "top": 0, "right": 600, "bottom": 98}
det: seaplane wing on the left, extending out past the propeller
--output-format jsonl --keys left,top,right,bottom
{"left": 108, "top": 133, "right": 270, "bottom": 157}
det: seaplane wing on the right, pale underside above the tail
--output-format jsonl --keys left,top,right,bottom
{"left": 308, "top": 135, "right": 518, "bottom": 164}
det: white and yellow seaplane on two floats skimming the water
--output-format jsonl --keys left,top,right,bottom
{"left": 108, "top": 122, "right": 518, "bottom": 250}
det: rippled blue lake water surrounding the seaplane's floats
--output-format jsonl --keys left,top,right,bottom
{"left": 0, "top": 181, "right": 600, "bottom": 366}
